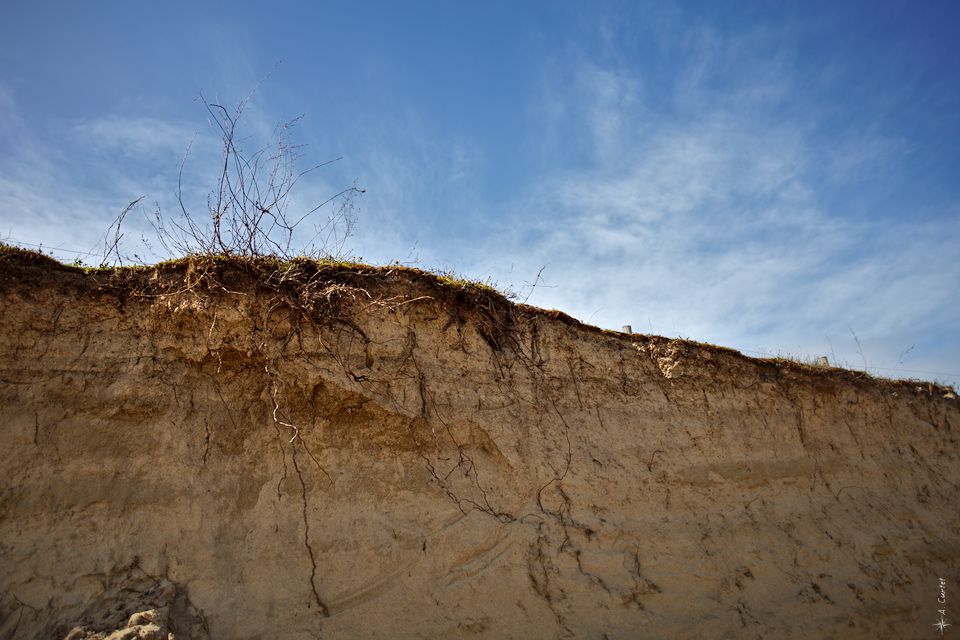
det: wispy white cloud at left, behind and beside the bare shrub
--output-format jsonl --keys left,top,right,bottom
{"left": 0, "top": 93, "right": 360, "bottom": 262}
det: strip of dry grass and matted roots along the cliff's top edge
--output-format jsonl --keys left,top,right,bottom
{"left": 0, "top": 244, "right": 955, "bottom": 395}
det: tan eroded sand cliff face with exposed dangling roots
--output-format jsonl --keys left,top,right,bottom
{"left": 0, "top": 251, "right": 960, "bottom": 639}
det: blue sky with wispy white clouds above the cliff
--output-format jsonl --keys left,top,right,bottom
{"left": 0, "top": 0, "right": 960, "bottom": 384}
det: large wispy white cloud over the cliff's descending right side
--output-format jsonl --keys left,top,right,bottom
{"left": 446, "top": 18, "right": 960, "bottom": 383}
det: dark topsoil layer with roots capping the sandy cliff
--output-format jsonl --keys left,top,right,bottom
{"left": 0, "top": 244, "right": 955, "bottom": 398}
